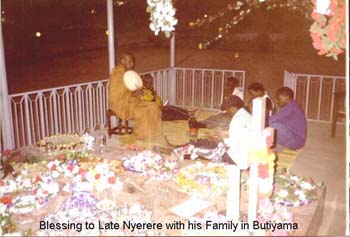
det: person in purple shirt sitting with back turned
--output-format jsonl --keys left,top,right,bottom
{"left": 269, "top": 87, "right": 306, "bottom": 150}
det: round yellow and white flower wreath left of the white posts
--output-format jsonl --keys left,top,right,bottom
{"left": 176, "top": 161, "right": 228, "bottom": 197}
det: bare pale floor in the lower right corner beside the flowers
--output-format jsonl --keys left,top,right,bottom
{"left": 291, "top": 122, "right": 348, "bottom": 236}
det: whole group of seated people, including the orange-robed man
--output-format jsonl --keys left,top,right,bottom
{"left": 109, "top": 53, "right": 306, "bottom": 156}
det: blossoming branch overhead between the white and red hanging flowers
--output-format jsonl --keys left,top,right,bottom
{"left": 189, "top": 0, "right": 312, "bottom": 49}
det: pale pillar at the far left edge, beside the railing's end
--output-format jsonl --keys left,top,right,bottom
{"left": 0, "top": 18, "right": 15, "bottom": 150}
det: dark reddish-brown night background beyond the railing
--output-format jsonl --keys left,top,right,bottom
{"left": 1, "top": 0, "right": 345, "bottom": 92}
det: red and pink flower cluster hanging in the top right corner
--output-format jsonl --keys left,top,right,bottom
{"left": 310, "top": 0, "right": 346, "bottom": 60}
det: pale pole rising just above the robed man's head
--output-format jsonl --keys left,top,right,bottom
{"left": 107, "top": 0, "right": 115, "bottom": 72}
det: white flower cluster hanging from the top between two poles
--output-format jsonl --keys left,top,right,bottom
{"left": 146, "top": 0, "right": 177, "bottom": 38}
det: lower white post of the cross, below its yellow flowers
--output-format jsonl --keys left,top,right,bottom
{"left": 248, "top": 162, "right": 258, "bottom": 227}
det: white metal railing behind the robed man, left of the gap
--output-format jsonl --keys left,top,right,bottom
{"left": 10, "top": 68, "right": 245, "bottom": 147}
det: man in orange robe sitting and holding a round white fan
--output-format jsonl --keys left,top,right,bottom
{"left": 109, "top": 53, "right": 162, "bottom": 140}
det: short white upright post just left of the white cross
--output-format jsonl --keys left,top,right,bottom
{"left": 226, "top": 165, "right": 241, "bottom": 222}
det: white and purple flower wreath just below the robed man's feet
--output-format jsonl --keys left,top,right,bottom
{"left": 123, "top": 151, "right": 179, "bottom": 180}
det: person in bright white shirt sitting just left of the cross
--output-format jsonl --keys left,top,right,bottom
{"left": 224, "top": 95, "right": 252, "bottom": 168}
